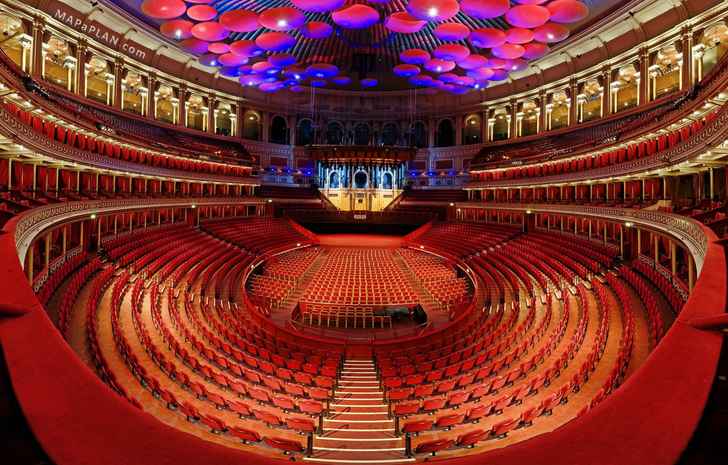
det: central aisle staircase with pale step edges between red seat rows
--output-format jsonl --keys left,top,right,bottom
{"left": 304, "top": 359, "right": 414, "bottom": 464}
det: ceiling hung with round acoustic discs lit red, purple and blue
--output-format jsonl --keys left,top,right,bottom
{"left": 114, "top": 0, "right": 623, "bottom": 94}
